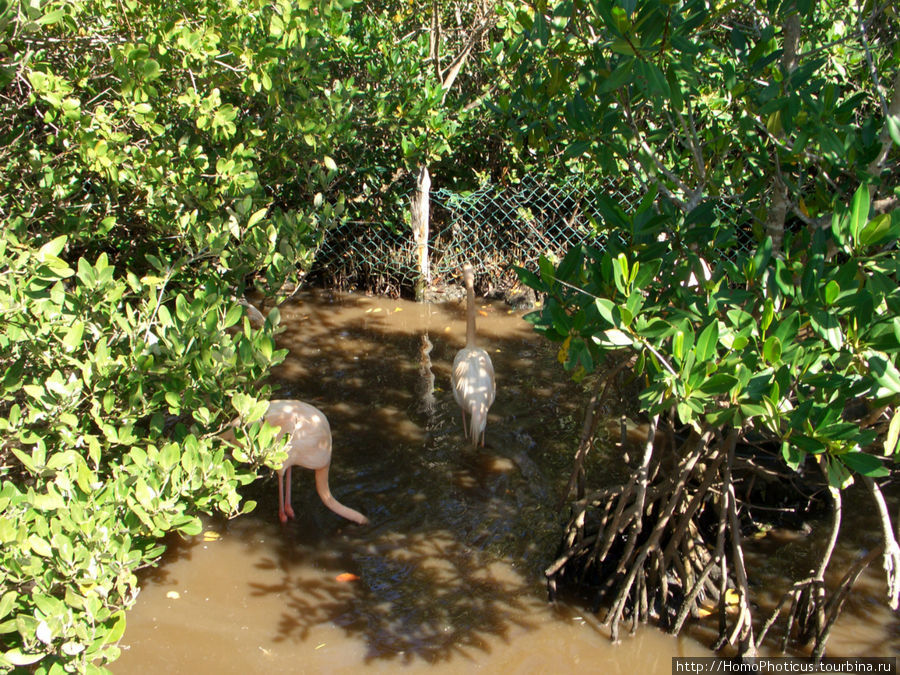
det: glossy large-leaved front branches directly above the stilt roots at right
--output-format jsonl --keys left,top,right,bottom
{"left": 520, "top": 186, "right": 900, "bottom": 487}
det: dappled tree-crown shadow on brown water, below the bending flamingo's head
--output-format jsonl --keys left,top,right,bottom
{"left": 249, "top": 531, "right": 539, "bottom": 664}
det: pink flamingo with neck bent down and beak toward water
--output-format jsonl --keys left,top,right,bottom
{"left": 225, "top": 399, "right": 369, "bottom": 525}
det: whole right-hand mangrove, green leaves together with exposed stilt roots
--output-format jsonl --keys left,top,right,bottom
{"left": 498, "top": 0, "right": 900, "bottom": 654}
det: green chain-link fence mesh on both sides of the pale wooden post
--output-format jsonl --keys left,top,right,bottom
{"left": 313, "top": 177, "right": 752, "bottom": 293}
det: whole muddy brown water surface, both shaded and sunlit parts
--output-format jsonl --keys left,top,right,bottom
{"left": 118, "top": 292, "right": 900, "bottom": 673}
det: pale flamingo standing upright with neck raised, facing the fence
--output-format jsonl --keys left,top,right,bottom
{"left": 451, "top": 263, "right": 497, "bottom": 447}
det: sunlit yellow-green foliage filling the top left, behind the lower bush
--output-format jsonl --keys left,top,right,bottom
{"left": 0, "top": 0, "right": 356, "bottom": 293}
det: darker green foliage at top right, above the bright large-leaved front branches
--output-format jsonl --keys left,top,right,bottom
{"left": 495, "top": 0, "right": 900, "bottom": 230}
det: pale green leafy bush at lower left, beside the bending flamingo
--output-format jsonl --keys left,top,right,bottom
{"left": 0, "top": 233, "right": 284, "bottom": 671}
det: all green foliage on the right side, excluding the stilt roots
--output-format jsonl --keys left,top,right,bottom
{"left": 504, "top": 0, "right": 900, "bottom": 486}
